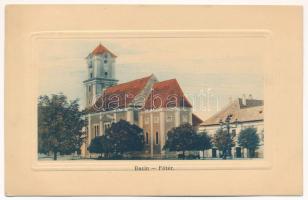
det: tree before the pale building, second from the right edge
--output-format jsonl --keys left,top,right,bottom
{"left": 213, "top": 128, "right": 235, "bottom": 159}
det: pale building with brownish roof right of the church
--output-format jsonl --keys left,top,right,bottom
{"left": 199, "top": 95, "right": 264, "bottom": 158}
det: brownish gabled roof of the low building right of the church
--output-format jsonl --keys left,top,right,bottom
{"left": 201, "top": 98, "right": 263, "bottom": 126}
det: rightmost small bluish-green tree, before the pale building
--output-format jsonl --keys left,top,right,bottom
{"left": 238, "top": 128, "right": 260, "bottom": 158}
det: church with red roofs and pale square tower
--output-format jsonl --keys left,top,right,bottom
{"left": 82, "top": 44, "right": 202, "bottom": 158}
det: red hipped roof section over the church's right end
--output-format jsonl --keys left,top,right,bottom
{"left": 145, "top": 79, "right": 192, "bottom": 109}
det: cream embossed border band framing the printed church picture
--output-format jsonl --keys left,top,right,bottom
{"left": 31, "top": 30, "right": 275, "bottom": 171}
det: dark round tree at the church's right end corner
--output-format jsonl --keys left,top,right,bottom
{"left": 163, "top": 123, "right": 197, "bottom": 158}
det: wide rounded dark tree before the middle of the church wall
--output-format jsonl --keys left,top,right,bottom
{"left": 103, "top": 120, "right": 144, "bottom": 156}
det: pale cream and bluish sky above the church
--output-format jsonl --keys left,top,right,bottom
{"left": 37, "top": 38, "right": 266, "bottom": 120}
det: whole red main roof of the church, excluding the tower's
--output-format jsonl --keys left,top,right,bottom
{"left": 88, "top": 75, "right": 192, "bottom": 112}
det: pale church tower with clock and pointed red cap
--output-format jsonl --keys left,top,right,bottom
{"left": 83, "top": 44, "right": 118, "bottom": 107}
